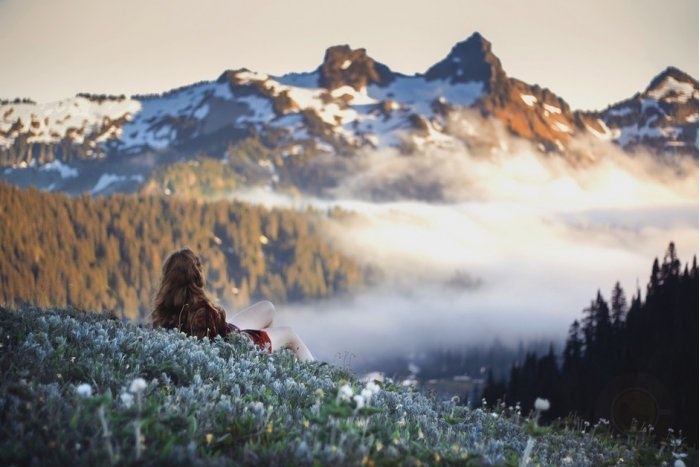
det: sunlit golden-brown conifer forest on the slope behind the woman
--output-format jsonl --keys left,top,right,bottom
{"left": 0, "top": 183, "right": 363, "bottom": 320}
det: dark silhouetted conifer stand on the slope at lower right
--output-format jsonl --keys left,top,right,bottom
{"left": 483, "top": 243, "right": 699, "bottom": 443}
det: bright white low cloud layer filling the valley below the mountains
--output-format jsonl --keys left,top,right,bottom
{"left": 228, "top": 133, "right": 698, "bottom": 370}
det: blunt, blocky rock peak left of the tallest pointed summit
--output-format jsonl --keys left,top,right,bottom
{"left": 317, "top": 45, "right": 395, "bottom": 91}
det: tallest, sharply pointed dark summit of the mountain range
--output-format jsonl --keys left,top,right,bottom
{"left": 425, "top": 32, "right": 506, "bottom": 90}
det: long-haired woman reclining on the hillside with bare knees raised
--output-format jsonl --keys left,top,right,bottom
{"left": 151, "top": 248, "right": 314, "bottom": 361}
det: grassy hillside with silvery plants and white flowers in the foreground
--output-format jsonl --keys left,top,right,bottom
{"left": 0, "top": 307, "right": 689, "bottom": 466}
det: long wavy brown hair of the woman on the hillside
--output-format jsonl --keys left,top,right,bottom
{"left": 151, "top": 248, "right": 227, "bottom": 338}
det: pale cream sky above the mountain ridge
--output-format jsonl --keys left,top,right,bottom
{"left": 0, "top": 0, "right": 698, "bottom": 109}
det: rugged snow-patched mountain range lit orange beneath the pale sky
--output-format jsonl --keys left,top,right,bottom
{"left": 0, "top": 33, "right": 698, "bottom": 194}
